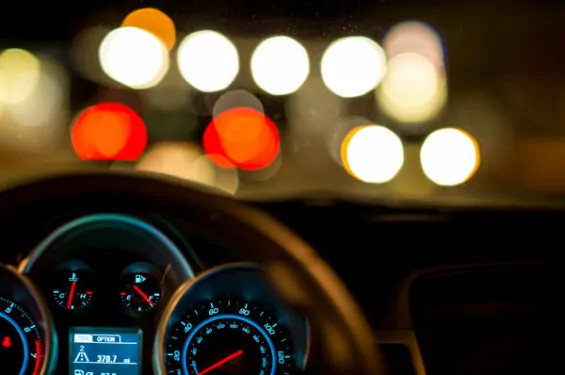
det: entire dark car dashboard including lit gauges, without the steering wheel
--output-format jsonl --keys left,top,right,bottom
{"left": 0, "top": 177, "right": 565, "bottom": 375}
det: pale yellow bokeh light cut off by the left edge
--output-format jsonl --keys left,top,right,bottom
{"left": 0, "top": 48, "right": 41, "bottom": 104}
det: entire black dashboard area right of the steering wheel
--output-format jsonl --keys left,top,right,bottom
{"left": 264, "top": 202, "right": 565, "bottom": 375}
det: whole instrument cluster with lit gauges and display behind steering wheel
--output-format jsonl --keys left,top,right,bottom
{"left": 0, "top": 214, "right": 309, "bottom": 375}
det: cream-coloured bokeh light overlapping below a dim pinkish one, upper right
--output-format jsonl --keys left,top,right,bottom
{"left": 377, "top": 53, "right": 447, "bottom": 123}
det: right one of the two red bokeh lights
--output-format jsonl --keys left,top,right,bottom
{"left": 203, "top": 107, "right": 280, "bottom": 170}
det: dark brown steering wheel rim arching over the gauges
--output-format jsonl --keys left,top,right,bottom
{"left": 0, "top": 172, "right": 382, "bottom": 375}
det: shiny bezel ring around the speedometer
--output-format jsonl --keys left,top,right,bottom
{"left": 153, "top": 263, "right": 311, "bottom": 374}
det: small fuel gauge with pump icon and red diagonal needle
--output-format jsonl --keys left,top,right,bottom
{"left": 120, "top": 266, "right": 161, "bottom": 314}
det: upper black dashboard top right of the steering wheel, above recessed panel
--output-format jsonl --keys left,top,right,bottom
{"left": 261, "top": 201, "right": 565, "bottom": 329}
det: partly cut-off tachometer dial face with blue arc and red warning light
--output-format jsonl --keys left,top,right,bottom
{"left": 0, "top": 297, "right": 45, "bottom": 375}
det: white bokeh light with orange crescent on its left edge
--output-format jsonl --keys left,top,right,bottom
{"left": 341, "top": 125, "right": 404, "bottom": 183}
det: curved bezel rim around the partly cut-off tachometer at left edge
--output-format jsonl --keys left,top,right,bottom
{"left": 0, "top": 264, "right": 57, "bottom": 375}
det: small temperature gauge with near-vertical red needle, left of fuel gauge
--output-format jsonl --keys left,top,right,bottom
{"left": 53, "top": 261, "right": 94, "bottom": 310}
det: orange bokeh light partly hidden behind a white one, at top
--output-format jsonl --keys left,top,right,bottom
{"left": 122, "top": 8, "right": 176, "bottom": 51}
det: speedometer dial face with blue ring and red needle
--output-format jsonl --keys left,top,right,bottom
{"left": 165, "top": 298, "right": 294, "bottom": 375}
